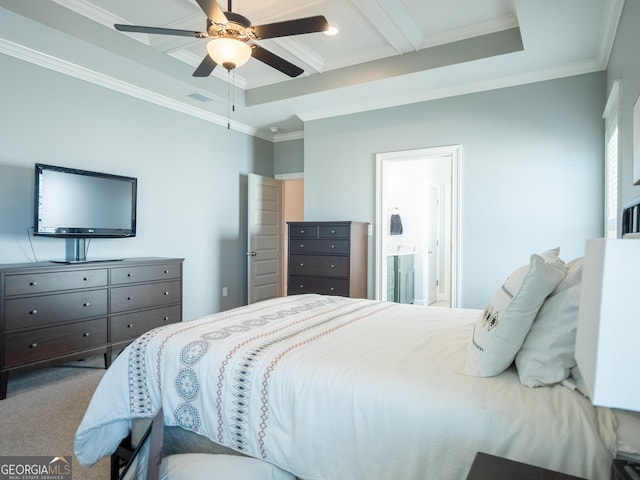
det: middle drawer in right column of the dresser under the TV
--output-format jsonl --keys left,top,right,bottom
{"left": 111, "top": 280, "right": 182, "bottom": 313}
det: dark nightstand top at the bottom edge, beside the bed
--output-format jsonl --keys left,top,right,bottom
{"left": 467, "top": 452, "right": 585, "bottom": 480}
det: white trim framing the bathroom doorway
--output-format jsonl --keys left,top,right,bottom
{"left": 374, "top": 145, "right": 462, "bottom": 308}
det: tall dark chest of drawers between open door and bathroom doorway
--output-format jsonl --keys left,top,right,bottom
{"left": 287, "top": 222, "right": 368, "bottom": 298}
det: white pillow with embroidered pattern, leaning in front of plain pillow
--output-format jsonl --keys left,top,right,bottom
{"left": 462, "top": 248, "right": 567, "bottom": 377}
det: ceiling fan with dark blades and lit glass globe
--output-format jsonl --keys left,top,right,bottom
{"left": 114, "top": 0, "right": 329, "bottom": 77}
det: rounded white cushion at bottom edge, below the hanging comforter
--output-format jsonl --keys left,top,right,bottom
{"left": 160, "top": 453, "right": 296, "bottom": 480}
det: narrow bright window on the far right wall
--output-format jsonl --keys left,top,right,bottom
{"left": 603, "top": 81, "right": 620, "bottom": 238}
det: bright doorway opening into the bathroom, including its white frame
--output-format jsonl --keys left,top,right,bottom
{"left": 375, "top": 145, "right": 461, "bottom": 307}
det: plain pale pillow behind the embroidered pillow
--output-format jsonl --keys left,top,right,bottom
{"left": 516, "top": 285, "right": 580, "bottom": 387}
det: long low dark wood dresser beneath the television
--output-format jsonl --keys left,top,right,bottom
{"left": 0, "top": 258, "right": 183, "bottom": 399}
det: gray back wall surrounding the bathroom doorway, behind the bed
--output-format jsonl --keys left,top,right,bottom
{"left": 304, "top": 72, "right": 606, "bottom": 308}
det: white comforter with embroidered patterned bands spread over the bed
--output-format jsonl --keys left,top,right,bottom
{"left": 75, "top": 295, "right": 615, "bottom": 480}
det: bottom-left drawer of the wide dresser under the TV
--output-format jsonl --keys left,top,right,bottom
{"left": 5, "top": 318, "right": 107, "bottom": 367}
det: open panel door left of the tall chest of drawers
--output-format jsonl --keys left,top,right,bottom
{"left": 247, "top": 174, "right": 282, "bottom": 303}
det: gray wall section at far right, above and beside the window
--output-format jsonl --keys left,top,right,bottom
{"left": 607, "top": 1, "right": 640, "bottom": 205}
